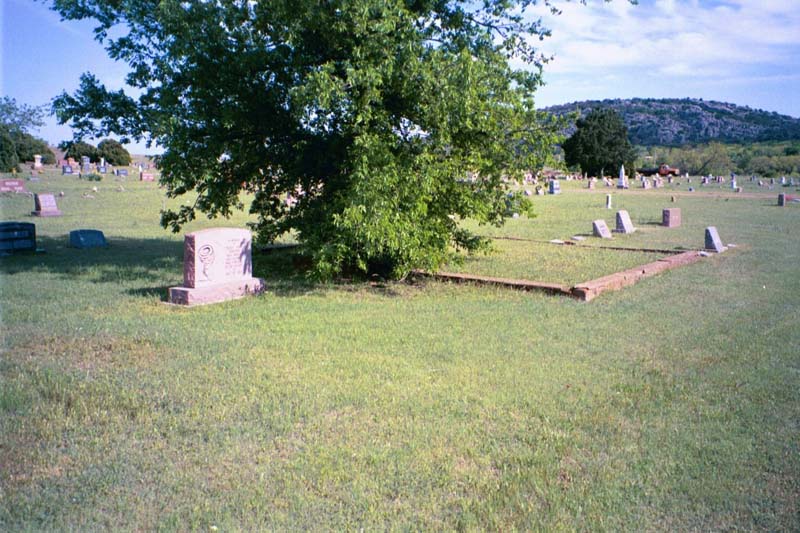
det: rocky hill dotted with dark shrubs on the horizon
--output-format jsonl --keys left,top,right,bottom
{"left": 545, "top": 98, "right": 800, "bottom": 146}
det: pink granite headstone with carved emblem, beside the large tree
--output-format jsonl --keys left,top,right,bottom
{"left": 169, "top": 228, "right": 265, "bottom": 305}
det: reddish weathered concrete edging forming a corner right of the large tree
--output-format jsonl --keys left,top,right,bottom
{"left": 413, "top": 251, "right": 703, "bottom": 302}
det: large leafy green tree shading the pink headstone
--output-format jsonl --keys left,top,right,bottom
{"left": 54, "top": 0, "right": 560, "bottom": 276}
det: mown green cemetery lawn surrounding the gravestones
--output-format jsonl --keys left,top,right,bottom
{"left": 0, "top": 173, "right": 800, "bottom": 531}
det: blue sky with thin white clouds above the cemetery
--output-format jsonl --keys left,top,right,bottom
{"left": 0, "top": 0, "right": 800, "bottom": 153}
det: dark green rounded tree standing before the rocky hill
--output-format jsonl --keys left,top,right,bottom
{"left": 561, "top": 109, "right": 636, "bottom": 176}
